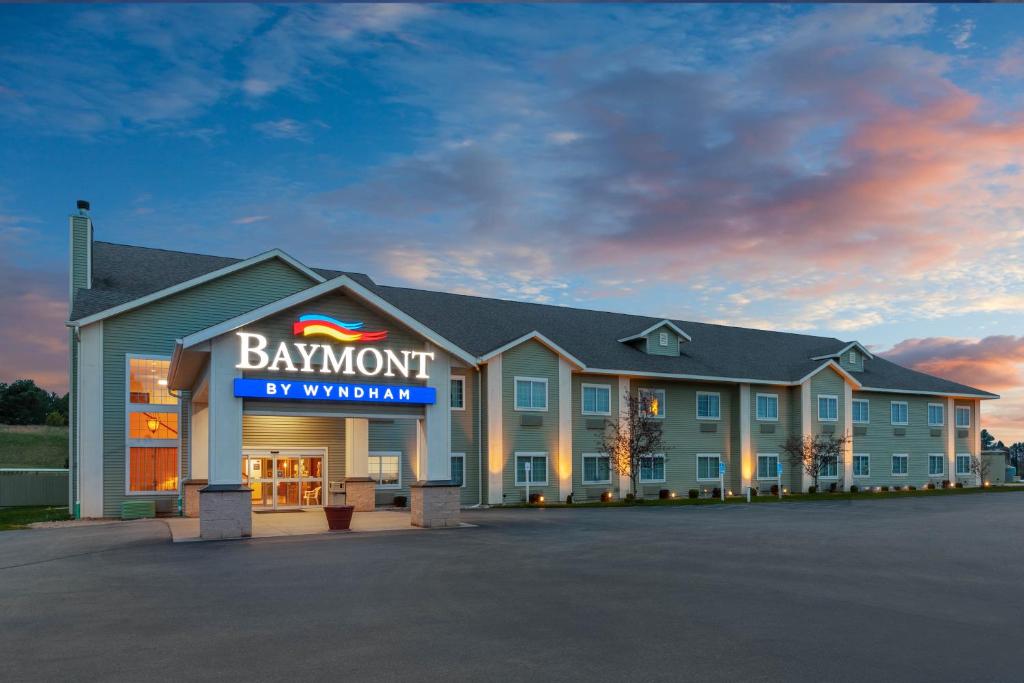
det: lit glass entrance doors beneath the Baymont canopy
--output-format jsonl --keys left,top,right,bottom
{"left": 242, "top": 450, "right": 324, "bottom": 510}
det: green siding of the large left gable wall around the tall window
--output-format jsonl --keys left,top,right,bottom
{"left": 103, "top": 259, "right": 311, "bottom": 517}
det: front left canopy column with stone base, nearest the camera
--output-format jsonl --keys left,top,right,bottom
{"left": 199, "top": 335, "right": 253, "bottom": 540}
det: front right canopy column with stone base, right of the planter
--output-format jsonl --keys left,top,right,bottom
{"left": 410, "top": 344, "right": 460, "bottom": 527}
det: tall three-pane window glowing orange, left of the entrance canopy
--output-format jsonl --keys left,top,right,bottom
{"left": 125, "top": 357, "right": 180, "bottom": 494}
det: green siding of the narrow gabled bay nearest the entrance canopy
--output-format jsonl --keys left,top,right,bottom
{"left": 502, "top": 341, "right": 559, "bottom": 503}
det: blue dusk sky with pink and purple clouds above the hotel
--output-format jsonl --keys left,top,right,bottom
{"left": 0, "top": 4, "right": 1024, "bottom": 443}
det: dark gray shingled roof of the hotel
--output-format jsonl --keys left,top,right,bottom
{"left": 72, "top": 242, "right": 994, "bottom": 396}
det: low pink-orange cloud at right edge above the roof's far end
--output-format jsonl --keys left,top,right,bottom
{"left": 882, "top": 335, "right": 1024, "bottom": 392}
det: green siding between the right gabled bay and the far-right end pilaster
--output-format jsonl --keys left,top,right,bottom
{"left": 852, "top": 391, "right": 950, "bottom": 487}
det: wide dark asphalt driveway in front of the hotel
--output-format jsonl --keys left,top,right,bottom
{"left": 0, "top": 494, "right": 1024, "bottom": 681}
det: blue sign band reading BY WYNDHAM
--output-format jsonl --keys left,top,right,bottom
{"left": 234, "top": 378, "right": 437, "bottom": 405}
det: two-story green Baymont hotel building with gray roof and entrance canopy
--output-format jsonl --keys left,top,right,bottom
{"left": 68, "top": 203, "right": 997, "bottom": 538}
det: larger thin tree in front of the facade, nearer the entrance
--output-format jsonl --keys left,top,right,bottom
{"left": 600, "top": 392, "right": 666, "bottom": 497}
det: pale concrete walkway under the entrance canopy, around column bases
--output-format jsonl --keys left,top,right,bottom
{"left": 163, "top": 510, "right": 472, "bottom": 543}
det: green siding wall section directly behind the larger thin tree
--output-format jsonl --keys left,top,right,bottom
{"left": 630, "top": 379, "right": 741, "bottom": 497}
